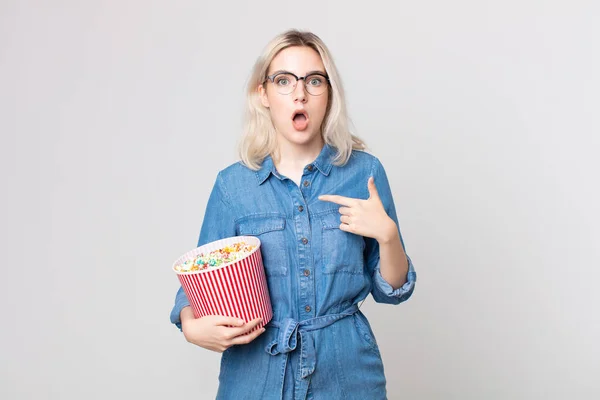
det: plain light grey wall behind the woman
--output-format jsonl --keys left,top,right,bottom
{"left": 0, "top": 0, "right": 600, "bottom": 400}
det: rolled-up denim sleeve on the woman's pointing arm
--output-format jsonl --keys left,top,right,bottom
{"left": 364, "top": 158, "right": 417, "bottom": 304}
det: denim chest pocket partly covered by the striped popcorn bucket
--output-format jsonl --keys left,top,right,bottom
{"left": 237, "top": 216, "right": 289, "bottom": 276}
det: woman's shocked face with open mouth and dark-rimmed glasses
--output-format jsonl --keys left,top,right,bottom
{"left": 259, "top": 47, "right": 329, "bottom": 151}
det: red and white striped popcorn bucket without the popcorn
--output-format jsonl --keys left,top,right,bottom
{"left": 172, "top": 236, "right": 273, "bottom": 331}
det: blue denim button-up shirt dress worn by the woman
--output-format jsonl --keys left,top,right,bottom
{"left": 171, "top": 144, "right": 416, "bottom": 400}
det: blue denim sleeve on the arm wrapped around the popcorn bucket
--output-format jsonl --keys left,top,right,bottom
{"left": 171, "top": 173, "right": 236, "bottom": 330}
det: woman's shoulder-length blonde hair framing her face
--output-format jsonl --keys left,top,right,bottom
{"left": 238, "top": 29, "right": 366, "bottom": 170}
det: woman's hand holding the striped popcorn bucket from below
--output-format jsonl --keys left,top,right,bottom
{"left": 180, "top": 306, "right": 265, "bottom": 353}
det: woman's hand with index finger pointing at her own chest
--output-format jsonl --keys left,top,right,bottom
{"left": 319, "top": 177, "right": 398, "bottom": 243}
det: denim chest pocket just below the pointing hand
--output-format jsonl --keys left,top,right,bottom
{"left": 321, "top": 210, "right": 365, "bottom": 274}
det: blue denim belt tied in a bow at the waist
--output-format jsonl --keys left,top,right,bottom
{"left": 265, "top": 304, "right": 358, "bottom": 388}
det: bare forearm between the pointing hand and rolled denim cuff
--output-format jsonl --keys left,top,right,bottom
{"left": 377, "top": 219, "right": 408, "bottom": 290}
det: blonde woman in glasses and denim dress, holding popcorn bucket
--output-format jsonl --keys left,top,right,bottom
{"left": 171, "top": 31, "right": 416, "bottom": 400}
